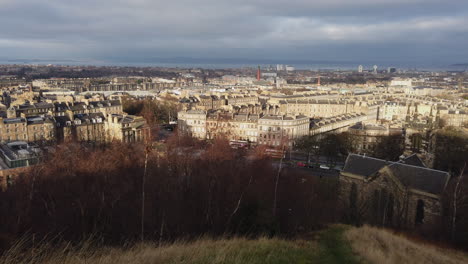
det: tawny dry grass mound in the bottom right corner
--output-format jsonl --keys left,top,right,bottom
{"left": 345, "top": 226, "right": 468, "bottom": 264}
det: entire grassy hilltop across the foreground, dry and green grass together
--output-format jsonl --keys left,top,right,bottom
{"left": 0, "top": 226, "right": 468, "bottom": 264}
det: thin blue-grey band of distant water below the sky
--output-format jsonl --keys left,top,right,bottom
{"left": 0, "top": 58, "right": 468, "bottom": 71}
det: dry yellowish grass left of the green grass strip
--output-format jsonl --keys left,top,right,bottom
{"left": 0, "top": 238, "right": 315, "bottom": 264}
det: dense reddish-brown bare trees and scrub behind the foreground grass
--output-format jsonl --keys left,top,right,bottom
{"left": 0, "top": 136, "right": 337, "bottom": 253}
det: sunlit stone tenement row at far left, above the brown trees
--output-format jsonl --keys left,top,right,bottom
{"left": 0, "top": 112, "right": 148, "bottom": 143}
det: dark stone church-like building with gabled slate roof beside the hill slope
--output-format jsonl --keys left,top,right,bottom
{"left": 340, "top": 154, "right": 450, "bottom": 228}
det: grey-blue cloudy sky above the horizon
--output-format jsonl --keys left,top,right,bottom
{"left": 0, "top": 0, "right": 468, "bottom": 63}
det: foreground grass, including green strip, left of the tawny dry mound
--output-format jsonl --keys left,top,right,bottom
{"left": 0, "top": 227, "right": 357, "bottom": 264}
